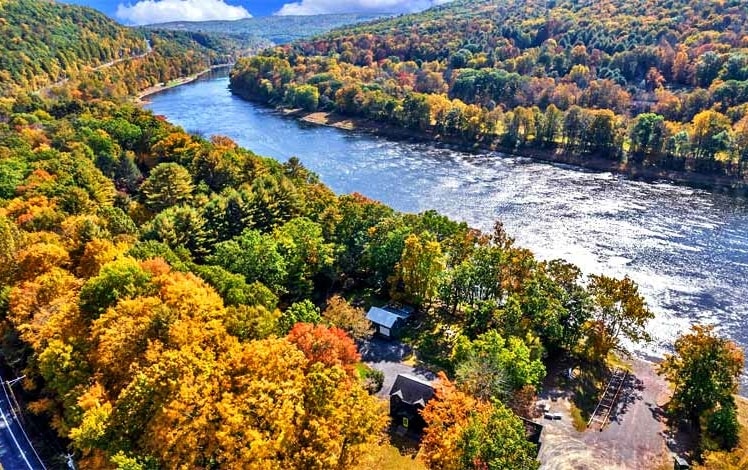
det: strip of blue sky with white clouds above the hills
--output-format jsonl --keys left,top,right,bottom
{"left": 63, "top": 0, "right": 450, "bottom": 25}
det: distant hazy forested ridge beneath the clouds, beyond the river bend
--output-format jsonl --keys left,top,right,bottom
{"left": 145, "top": 14, "right": 388, "bottom": 54}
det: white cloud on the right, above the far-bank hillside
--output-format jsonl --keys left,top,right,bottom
{"left": 276, "top": 0, "right": 451, "bottom": 15}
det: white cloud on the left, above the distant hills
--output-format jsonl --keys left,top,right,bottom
{"left": 116, "top": 0, "right": 252, "bottom": 25}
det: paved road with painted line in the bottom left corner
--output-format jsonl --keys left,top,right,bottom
{"left": 0, "top": 377, "right": 46, "bottom": 470}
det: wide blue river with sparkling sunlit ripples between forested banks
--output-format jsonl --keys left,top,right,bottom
{"left": 147, "top": 75, "right": 748, "bottom": 394}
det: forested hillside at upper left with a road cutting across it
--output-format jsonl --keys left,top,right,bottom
{"left": 0, "top": 0, "right": 229, "bottom": 96}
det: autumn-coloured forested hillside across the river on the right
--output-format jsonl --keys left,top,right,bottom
{"left": 232, "top": 0, "right": 748, "bottom": 179}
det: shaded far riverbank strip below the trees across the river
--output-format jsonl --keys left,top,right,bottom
{"left": 282, "top": 108, "right": 748, "bottom": 197}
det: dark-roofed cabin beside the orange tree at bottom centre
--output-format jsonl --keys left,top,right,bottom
{"left": 390, "top": 374, "right": 434, "bottom": 434}
